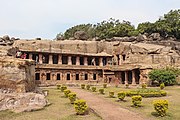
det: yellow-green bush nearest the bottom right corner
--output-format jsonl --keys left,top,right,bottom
{"left": 153, "top": 100, "right": 168, "bottom": 117}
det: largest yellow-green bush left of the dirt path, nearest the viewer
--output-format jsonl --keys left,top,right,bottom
{"left": 74, "top": 100, "right": 88, "bottom": 115}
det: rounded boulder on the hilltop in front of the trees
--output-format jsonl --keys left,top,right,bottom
{"left": 74, "top": 31, "right": 89, "bottom": 40}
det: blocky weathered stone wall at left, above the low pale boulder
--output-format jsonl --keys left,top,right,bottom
{"left": 0, "top": 56, "right": 35, "bottom": 92}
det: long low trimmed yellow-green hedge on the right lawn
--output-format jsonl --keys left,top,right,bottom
{"left": 126, "top": 89, "right": 167, "bottom": 98}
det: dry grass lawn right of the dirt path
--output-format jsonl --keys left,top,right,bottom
{"left": 88, "top": 86, "right": 180, "bottom": 120}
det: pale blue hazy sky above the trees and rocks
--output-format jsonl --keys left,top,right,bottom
{"left": 0, "top": 0, "right": 180, "bottom": 39}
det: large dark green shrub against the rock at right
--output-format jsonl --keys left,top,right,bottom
{"left": 148, "top": 69, "right": 176, "bottom": 85}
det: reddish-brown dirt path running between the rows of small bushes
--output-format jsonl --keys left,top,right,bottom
{"left": 69, "top": 88, "right": 144, "bottom": 120}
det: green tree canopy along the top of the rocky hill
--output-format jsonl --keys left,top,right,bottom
{"left": 56, "top": 9, "right": 180, "bottom": 39}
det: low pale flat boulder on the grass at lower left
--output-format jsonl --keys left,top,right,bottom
{"left": 0, "top": 93, "right": 49, "bottom": 113}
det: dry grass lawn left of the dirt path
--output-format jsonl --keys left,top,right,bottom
{"left": 0, "top": 88, "right": 101, "bottom": 120}
